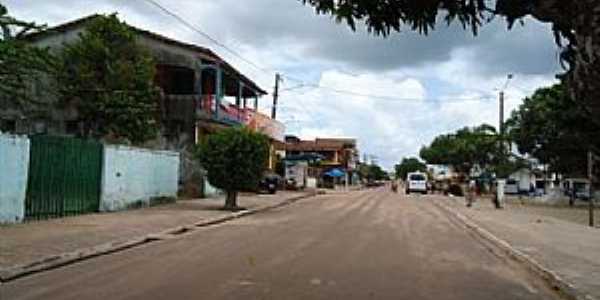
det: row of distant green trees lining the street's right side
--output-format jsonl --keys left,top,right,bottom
{"left": 408, "top": 80, "right": 600, "bottom": 188}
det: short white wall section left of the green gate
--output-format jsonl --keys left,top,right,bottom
{"left": 0, "top": 133, "right": 30, "bottom": 223}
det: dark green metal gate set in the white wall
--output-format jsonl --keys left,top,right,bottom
{"left": 25, "top": 136, "right": 102, "bottom": 219}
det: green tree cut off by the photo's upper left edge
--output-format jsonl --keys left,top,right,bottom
{"left": 0, "top": 4, "right": 55, "bottom": 110}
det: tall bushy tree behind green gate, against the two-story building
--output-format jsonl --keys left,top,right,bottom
{"left": 58, "top": 14, "right": 158, "bottom": 144}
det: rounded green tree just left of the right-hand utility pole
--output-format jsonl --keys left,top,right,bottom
{"left": 420, "top": 125, "right": 500, "bottom": 175}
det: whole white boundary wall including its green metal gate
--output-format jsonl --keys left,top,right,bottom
{"left": 0, "top": 134, "right": 180, "bottom": 223}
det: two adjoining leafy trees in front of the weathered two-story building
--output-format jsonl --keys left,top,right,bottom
{"left": 0, "top": 8, "right": 159, "bottom": 144}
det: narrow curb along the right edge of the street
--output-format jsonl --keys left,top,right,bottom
{"left": 433, "top": 201, "right": 596, "bottom": 300}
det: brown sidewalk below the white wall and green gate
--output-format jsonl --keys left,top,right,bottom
{"left": 0, "top": 192, "right": 307, "bottom": 271}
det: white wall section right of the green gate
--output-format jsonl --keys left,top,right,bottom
{"left": 100, "top": 145, "right": 180, "bottom": 211}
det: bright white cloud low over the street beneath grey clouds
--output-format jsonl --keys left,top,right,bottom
{"left": 282, "top": 68, "right": 552, "bottom": 168}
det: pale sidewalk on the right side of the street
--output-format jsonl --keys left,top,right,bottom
{"left": 435, "top": 198, "right": 600, "bottom": 299}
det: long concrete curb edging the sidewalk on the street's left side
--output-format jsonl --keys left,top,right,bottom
{"left": 0, "top": 193, "right": 317, "bottom": 285}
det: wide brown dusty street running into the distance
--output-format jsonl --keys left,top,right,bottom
{"left": 0, "top": 189, "right": 555, "bottom": 300}
